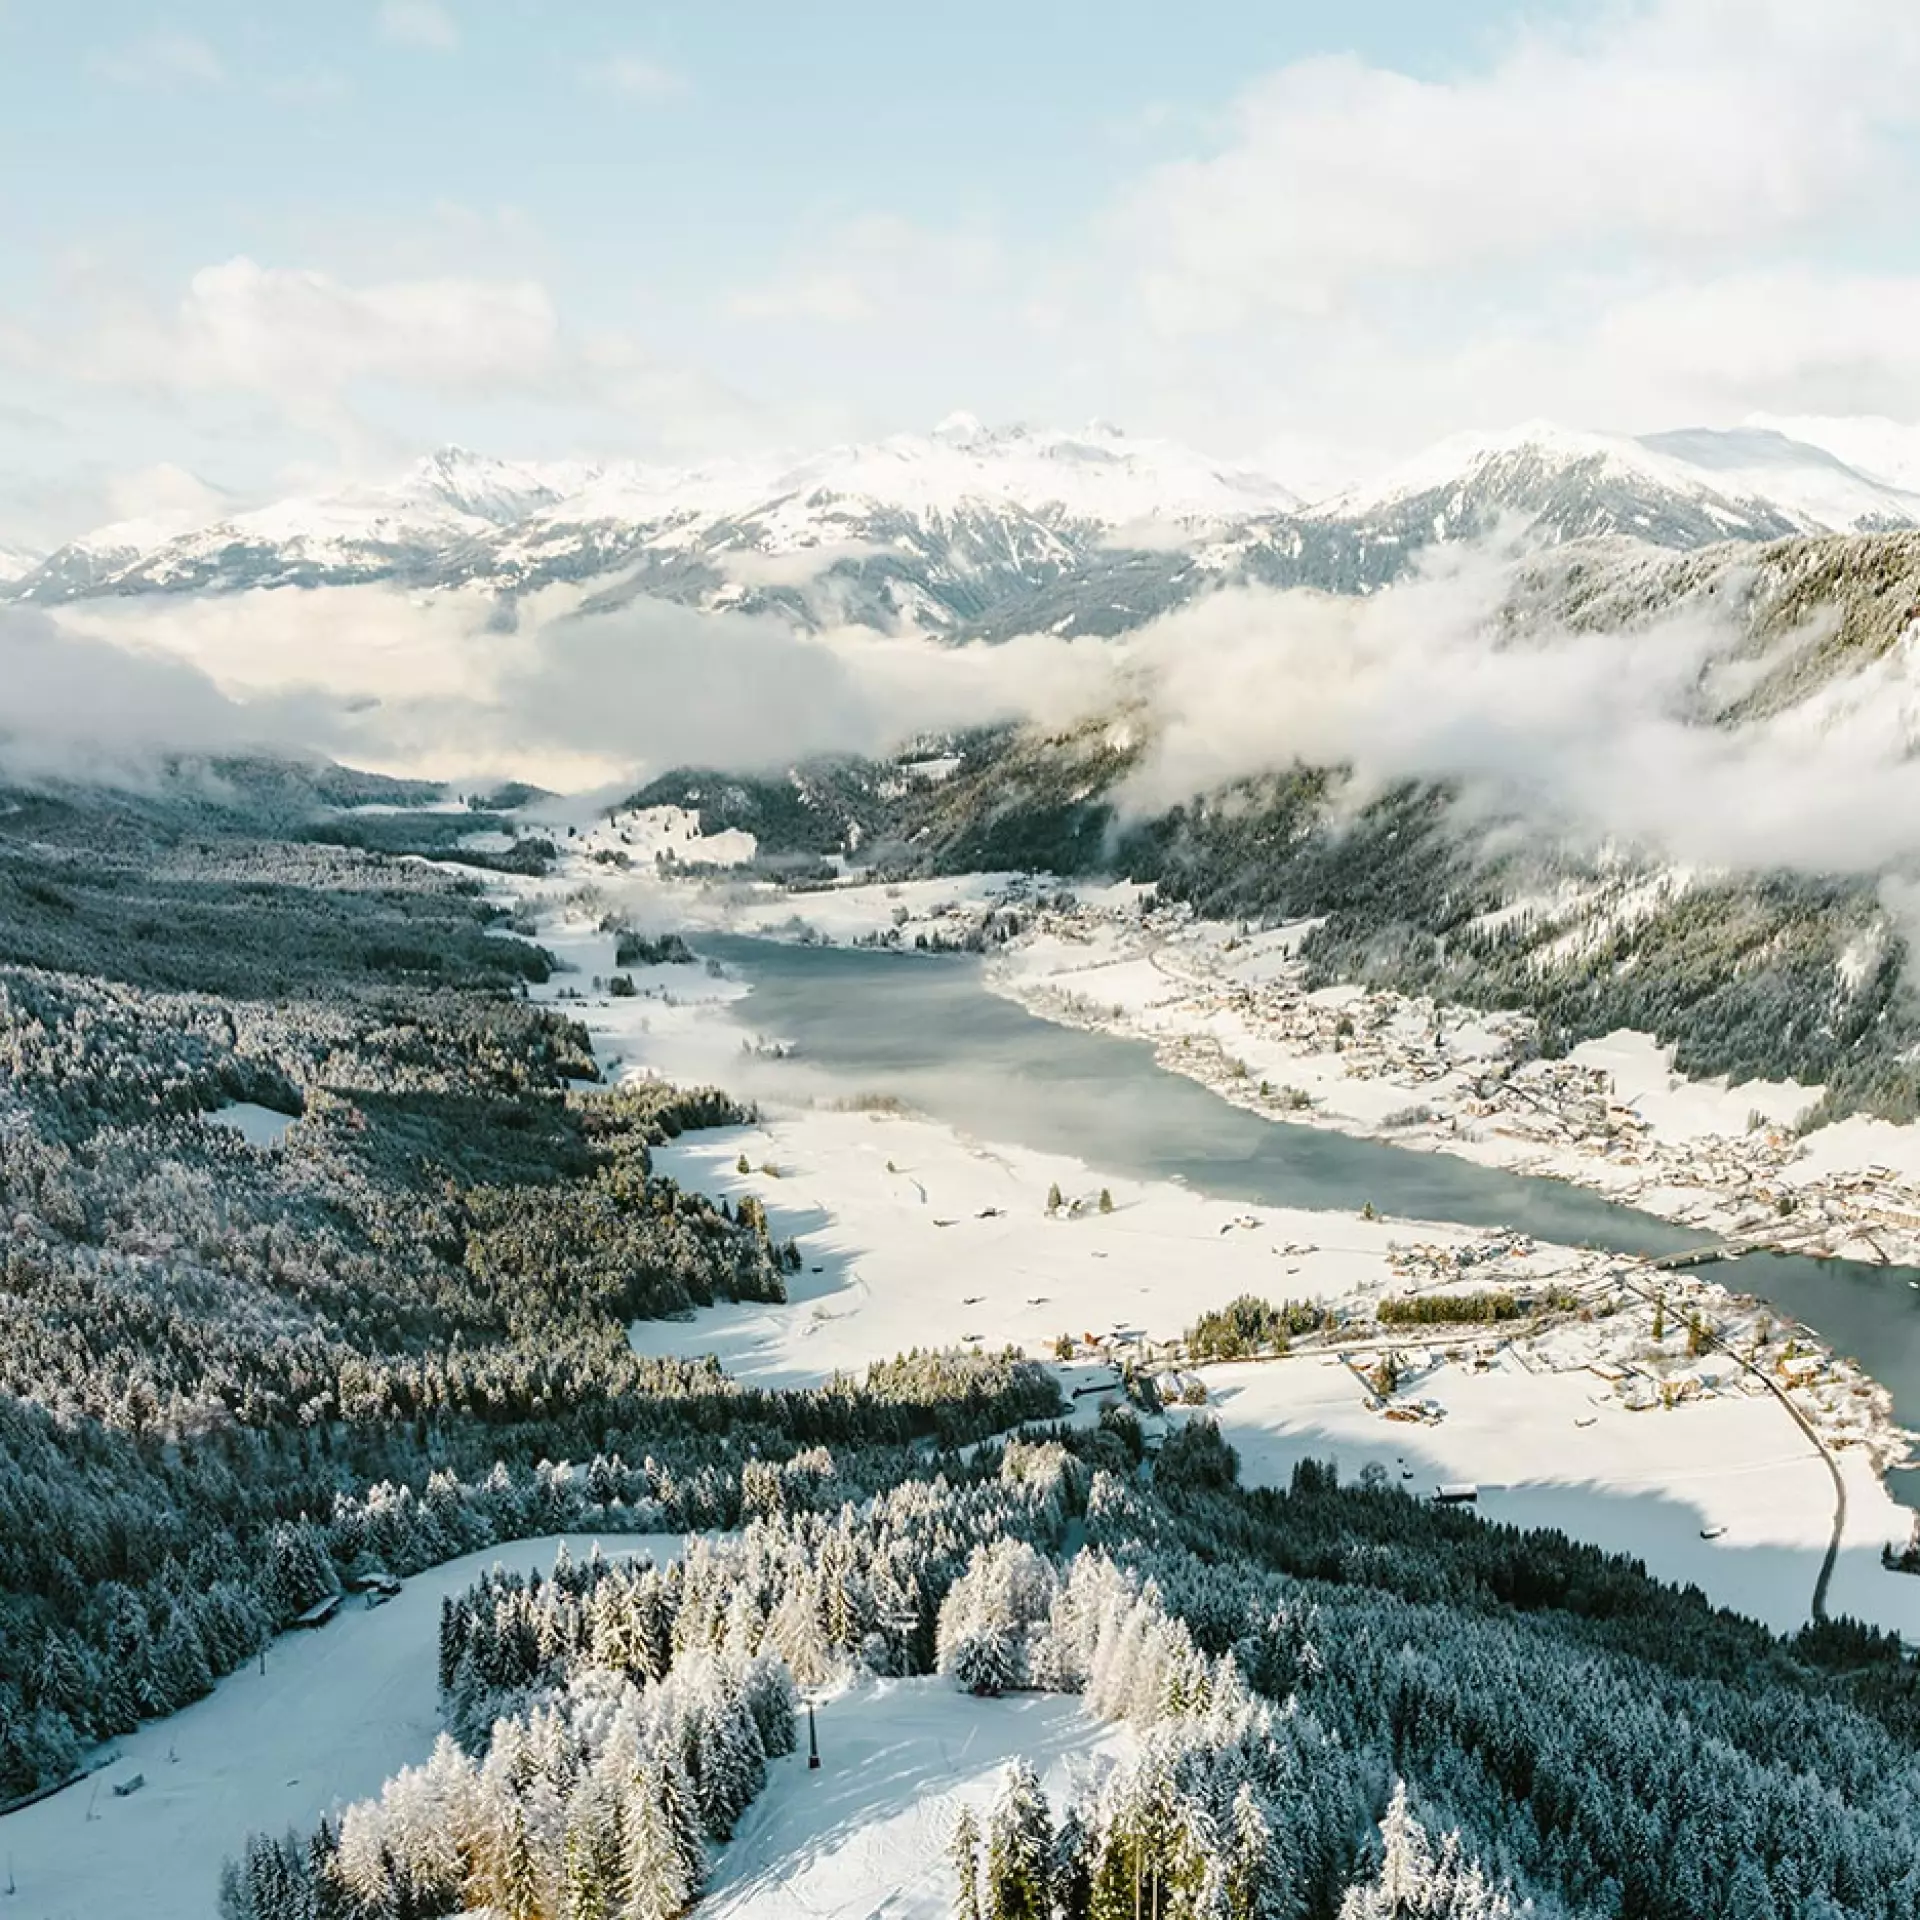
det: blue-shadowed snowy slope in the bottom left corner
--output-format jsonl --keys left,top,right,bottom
{"left": 0, "top": 1534, "right": 682, "bottom": 1920}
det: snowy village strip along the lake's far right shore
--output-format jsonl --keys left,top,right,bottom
{"left": 975, "top": 889, "right": 1920, "bottom": 1265}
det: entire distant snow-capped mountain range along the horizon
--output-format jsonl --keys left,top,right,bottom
{"left": 15, "top": 415, "right": 1920, "bottom": 637}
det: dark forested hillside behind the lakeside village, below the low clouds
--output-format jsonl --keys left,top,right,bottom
{"left": 630, "top": 706, "right": 1920, "bottom": 1121}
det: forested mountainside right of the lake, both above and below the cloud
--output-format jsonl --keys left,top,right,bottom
{"left": 634, "top": 532, "right": 1920, "bottom": 1121}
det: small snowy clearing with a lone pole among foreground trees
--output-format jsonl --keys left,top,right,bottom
{"left": 699, "top": 1678, "right": 1131, "bottom": 1920}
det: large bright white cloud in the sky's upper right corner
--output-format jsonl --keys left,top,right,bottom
{"left": 1116, "top": 0, "right": 1920, "bottom": 332}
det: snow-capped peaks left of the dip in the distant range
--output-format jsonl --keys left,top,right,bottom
{"left": 15, "top": 415, "right": 1296, "bottom": 632}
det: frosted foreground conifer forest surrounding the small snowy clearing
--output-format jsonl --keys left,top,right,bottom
{"left": 230, "top": 1421, "right": 1920, "bottom": 1920}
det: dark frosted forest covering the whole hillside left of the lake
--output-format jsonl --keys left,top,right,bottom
{"left": 0, "top": 780, "right": 1056, "bottom": 1803}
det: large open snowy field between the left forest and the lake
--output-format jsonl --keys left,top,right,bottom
{"left": 634, "top": 1113, "right": 1528, "bottom": 1386}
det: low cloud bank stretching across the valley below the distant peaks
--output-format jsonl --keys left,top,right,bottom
{"left": 22, "top": 555, "right": 1920, "bottom": 872}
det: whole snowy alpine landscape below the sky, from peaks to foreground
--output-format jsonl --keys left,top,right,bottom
{"left": 22, "top": 415, "right": 1920, "bottom": 1920}
